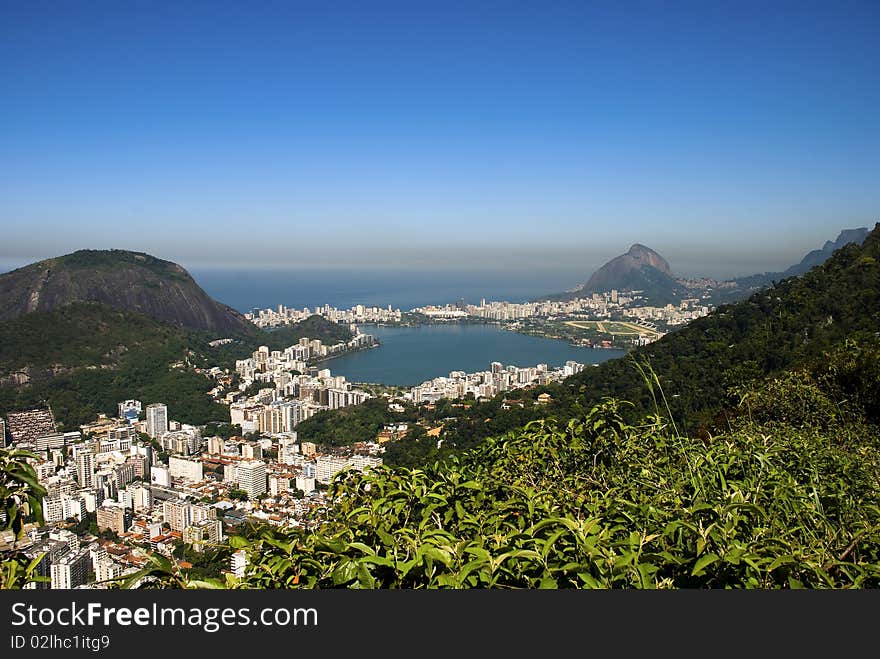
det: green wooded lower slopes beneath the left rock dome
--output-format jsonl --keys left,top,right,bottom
{"left": 0, "top": 302, "right": 351, "bottom": 430}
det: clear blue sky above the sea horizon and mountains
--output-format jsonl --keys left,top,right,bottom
{"left": 0, "top": 0, "right": 880, "bottom": 275}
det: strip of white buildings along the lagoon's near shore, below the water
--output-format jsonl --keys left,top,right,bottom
{"left": 408, "top": 361, "right": 584, "bottom": 404}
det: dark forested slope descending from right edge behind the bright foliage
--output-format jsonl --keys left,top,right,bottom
{"left": 559, "top": 224, "right": 880, "bottom": 427}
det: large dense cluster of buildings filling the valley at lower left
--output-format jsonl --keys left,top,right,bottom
{"left": 0, "top": 400, "right": 382, "bottom": 588}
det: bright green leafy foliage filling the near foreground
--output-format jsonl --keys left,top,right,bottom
{"left": 122, "top": 344, "right": 880, "bottom": 588}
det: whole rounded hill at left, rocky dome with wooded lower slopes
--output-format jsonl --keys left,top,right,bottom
{"left": 0, "top": 250, "right": 351, "bottom": 429}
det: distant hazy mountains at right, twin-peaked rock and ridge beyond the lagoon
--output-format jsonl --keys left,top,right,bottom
{"left": 546, "top": 227, "right": 869, "bottom": 306}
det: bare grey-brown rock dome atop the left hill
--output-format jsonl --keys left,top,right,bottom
{"left": 0, "top": 250, "right": 253, "bottom": 333}
